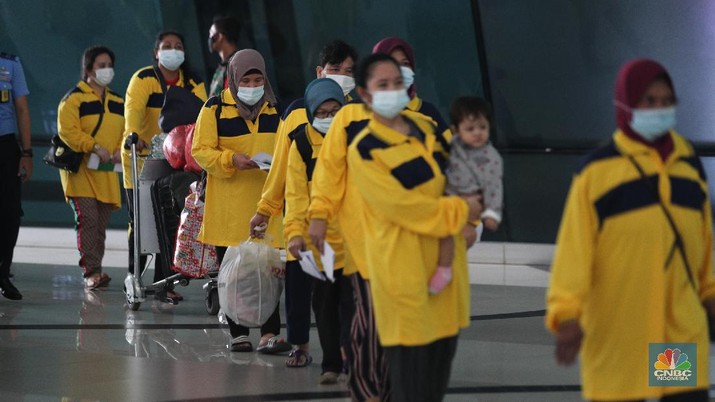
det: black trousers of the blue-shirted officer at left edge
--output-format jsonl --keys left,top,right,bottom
{"left": 0, "top": 134, "right": 22, "bottom": 278}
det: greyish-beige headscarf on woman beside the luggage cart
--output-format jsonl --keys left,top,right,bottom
{"left": 228, "top": 49, "right": 277, "bottom": 121}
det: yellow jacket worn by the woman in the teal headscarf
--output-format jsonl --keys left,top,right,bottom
{"left": 283, "top": 124, "right": 345, "bottom": 269}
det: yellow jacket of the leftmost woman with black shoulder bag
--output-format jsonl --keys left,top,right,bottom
{"left": 57, "top": 81, "right": 124, "bottom": 209}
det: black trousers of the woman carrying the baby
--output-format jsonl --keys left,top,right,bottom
{"left": 384, "top": 336, "right": 457, "bottom": 402}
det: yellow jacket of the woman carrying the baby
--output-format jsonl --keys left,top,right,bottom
{"left": 348, "top": 112, "right": 469, "bottom": 346}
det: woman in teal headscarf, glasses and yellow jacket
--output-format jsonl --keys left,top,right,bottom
{"left": 283, "top": 78, "right": 352, "bottom": 384}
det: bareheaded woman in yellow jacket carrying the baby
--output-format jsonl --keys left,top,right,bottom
{"left": 347, "top": 53, "right": 481, "bottom": 401}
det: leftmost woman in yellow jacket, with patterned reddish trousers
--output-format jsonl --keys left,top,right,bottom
{"left": 57, "top": 46, "right": 124, "bottom": 289}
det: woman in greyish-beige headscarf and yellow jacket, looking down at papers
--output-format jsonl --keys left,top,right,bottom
{"left": 191, "top": 49, "right": 290, "bottom": 353}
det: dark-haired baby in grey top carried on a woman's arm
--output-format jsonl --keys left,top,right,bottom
{"left": 429, "top": 96, "right": 504, "bottom": 294}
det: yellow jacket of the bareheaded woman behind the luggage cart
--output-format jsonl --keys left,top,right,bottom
{"left": 122, "top": 66, "right": 206, "bottom": 189}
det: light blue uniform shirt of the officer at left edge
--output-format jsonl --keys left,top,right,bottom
{"left": 0, "top": 53, "right": 30, "bottom": 135}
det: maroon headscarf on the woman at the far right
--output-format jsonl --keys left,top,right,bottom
{"left": 616, "top": 59, "right": 675, "bottom": 160}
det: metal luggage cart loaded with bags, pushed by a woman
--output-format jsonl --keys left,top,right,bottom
{"left": 124, "top": 133, "right": 189, "bottom": 311}
